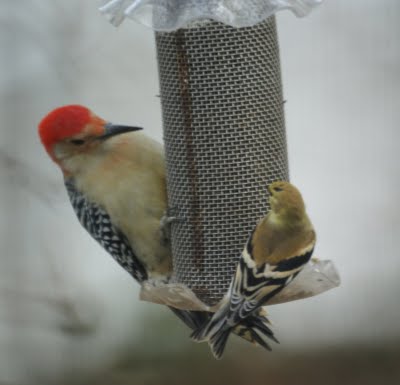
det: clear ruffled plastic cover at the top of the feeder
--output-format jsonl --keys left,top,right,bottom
{"left": 99, "top": 0, "right": 322, "bottom": 31}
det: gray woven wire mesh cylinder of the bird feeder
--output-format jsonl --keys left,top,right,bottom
{"left": 156, "top": 17, "right": 288, "bottom": 305}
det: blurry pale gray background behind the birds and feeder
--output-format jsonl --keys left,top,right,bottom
{"left": 0, "top": 0, "right": 400, "bottom": 384}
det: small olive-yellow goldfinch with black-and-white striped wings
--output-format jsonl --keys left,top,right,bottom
{"left": 192, "top": 181, "right": 316, "bottom": 358}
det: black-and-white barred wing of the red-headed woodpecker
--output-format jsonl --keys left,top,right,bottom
{"left": 65, "top": 181, "right": 147, "bottom": 282}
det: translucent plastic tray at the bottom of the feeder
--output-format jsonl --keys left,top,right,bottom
{"left": 140, "top": 258, "right": 340, "bottom": 311}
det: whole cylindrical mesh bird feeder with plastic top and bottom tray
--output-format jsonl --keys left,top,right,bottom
{"left": 101, "top": 0, "right": 339, "bottom": 310}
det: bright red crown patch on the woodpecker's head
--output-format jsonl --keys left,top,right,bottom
{"left": 39, "top": 105, "right": 92, "bottom": 153}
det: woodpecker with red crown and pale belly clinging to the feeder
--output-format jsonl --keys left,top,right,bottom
{"left": 39, "top": 105, "right": 273, "bottom": 347}
